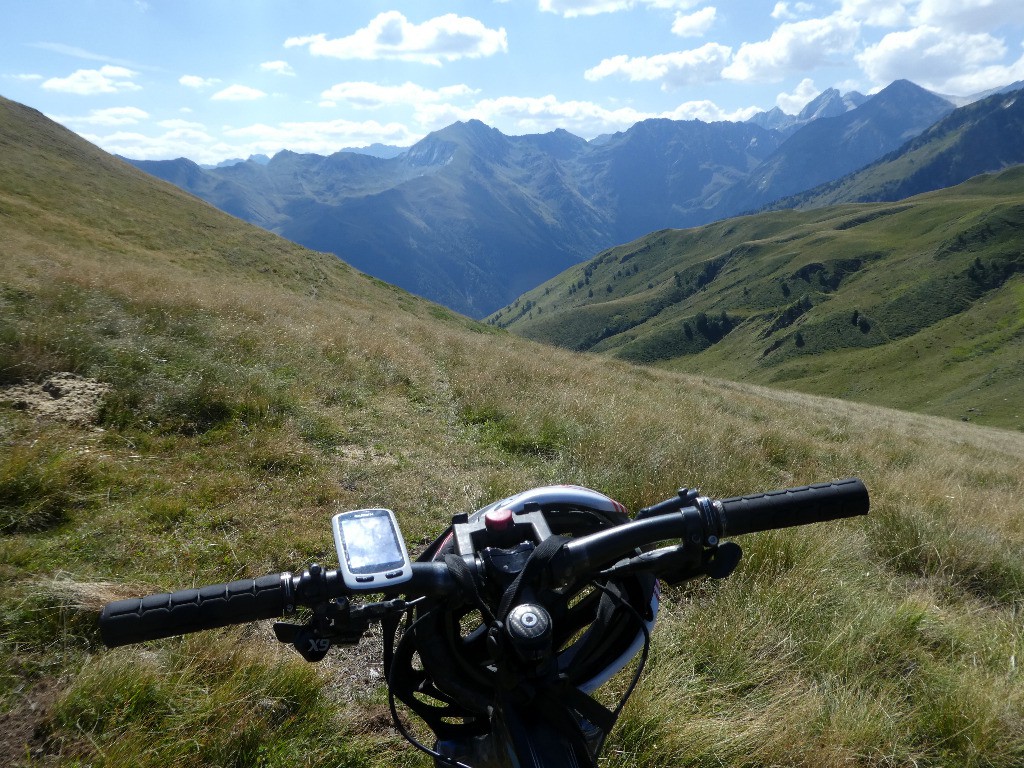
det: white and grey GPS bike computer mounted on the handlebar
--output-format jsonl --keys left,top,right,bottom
{"left": 331, "top": 509, "right": 413, "bottom": 592}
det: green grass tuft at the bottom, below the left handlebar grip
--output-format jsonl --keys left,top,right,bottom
{"left": 46, "top": 640, "right": 403, "bottom": 767}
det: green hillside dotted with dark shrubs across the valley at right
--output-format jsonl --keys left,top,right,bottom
{"left": 490, "top": 167, "right": 1024, "bottom": 429}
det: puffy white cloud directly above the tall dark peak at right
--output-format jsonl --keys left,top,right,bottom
{"left": 856, "top": 27, "right": 1021, "bottom": 95}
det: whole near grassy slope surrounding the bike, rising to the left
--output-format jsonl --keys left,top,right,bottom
{"left": 0, "top": 101, "right": 1024, "bottom": 768}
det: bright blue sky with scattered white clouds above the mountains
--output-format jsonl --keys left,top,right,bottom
{"left": 0, "top": 0, "right": 1024, "bottom": 164}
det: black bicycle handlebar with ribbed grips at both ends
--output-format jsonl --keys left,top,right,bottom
{"left": 99, "top": 478, "right": 868, "bottom": 647}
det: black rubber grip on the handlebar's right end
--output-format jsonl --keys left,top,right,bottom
{"left": 717, "top": 477, "right": 869, "bottom": 536}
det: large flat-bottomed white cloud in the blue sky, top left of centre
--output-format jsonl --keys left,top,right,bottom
{"left": 285, "top": 10, "right": 508, "bottom": 66}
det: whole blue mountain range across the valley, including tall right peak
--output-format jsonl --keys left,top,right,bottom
{"left": 121, "top": 81, "right": 1024, "bottom": 317}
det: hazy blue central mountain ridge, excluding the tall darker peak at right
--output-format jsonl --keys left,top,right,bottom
{"left": 133, "top": 121, "right": 777, "bottom": 316}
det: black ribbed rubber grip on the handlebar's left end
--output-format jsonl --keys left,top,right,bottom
{"left": 99, "top": 573, "right": 291, "bottom": 647}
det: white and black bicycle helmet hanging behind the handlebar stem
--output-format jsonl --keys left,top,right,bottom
{"left": 389, "top": 485, "right": 658, "bottom": 738}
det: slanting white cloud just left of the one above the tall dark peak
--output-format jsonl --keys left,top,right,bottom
{"left": 722, "top": 14, "right": 860, "bottom": 81}
